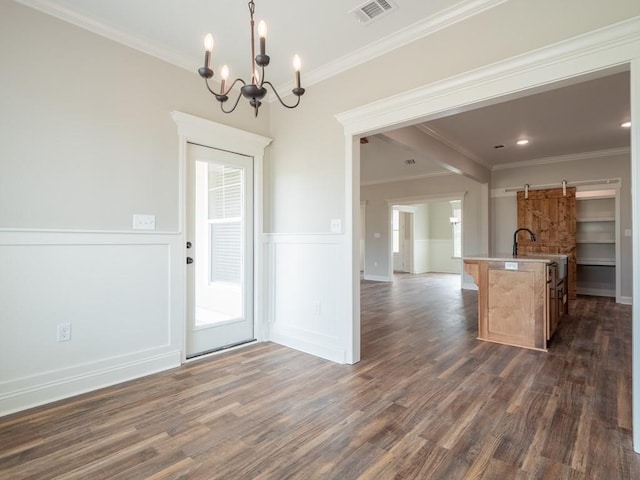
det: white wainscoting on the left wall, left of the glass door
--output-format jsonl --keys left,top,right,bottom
{"left": 0, "top": 231, "right": 184, "bottom": 415}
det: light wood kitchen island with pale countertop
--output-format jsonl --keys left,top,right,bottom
{"left": 463, "top": 254, "right": 567, "bottom": 351}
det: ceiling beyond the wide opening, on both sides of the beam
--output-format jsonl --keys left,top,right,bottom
{"left": 361, "top": 67, "right": 631, "bottom": 185}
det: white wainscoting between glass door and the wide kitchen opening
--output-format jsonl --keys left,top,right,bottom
{"left": 265, "top": 234, "right": 351, "bottom": 363}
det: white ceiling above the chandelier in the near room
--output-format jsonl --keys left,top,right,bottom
{"left": 16, "top": 0, "right": 506, "bottom": 86}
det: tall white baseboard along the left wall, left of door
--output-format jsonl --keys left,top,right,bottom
{"left": 0, "top": 351, "right": 181, "bottom": 416}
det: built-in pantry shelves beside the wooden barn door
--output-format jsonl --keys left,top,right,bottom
{"left": 576, "top": 190, "right": 618, "bottom": 297}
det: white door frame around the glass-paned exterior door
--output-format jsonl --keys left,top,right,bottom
{"left": 171, "top": 111, "right": 272, "bottom": 363}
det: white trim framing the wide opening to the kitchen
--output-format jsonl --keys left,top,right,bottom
{"left": 336, "top": 17, "right": 640, "bottom": 453}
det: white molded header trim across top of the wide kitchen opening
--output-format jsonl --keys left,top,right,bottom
{"left": 335, "top": 16, "right": 640, "bottom": 135}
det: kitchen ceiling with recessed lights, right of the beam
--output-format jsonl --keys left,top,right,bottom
{"left": 423, "top": 72, "right": 631, "bottom": 168}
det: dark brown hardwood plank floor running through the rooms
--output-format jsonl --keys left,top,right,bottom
{"left": 0, "top": 274, "right": 640, "bottom": 480}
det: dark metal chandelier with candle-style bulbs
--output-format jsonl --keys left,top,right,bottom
{"left": 198, "top": 0, "right": 304, "bottom": 117}
